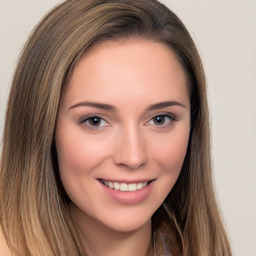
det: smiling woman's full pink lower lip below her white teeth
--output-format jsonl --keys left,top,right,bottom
{"left": 100, "top": 181, "right": 154, "bottom": 204}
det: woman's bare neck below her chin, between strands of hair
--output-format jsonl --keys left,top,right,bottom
{"left": 73, "top": 206, "right": 151, "bottom": 256}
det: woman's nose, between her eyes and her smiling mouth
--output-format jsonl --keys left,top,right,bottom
{"left": 114, "top": 127, "right": 147, "bottom": 170}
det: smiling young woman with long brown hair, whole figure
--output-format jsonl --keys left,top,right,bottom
{"left": 0, "top": 0, "right": 231, "bottom": 256}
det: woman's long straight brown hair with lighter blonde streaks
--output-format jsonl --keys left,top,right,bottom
{"left": 0, "top": 0, "right": 231, "bottom": 256}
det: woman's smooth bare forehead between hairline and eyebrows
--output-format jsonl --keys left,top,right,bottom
{"left": 63, "top": 40, "right": 188, "bottom": 109}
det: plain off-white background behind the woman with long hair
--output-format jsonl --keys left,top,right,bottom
{"left": 0, "top": 0, "right": 256, "bottom": 256}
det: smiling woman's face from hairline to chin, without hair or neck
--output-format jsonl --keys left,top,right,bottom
{"left": 56, "top": 40, "right": 190, "bottom": 232}
